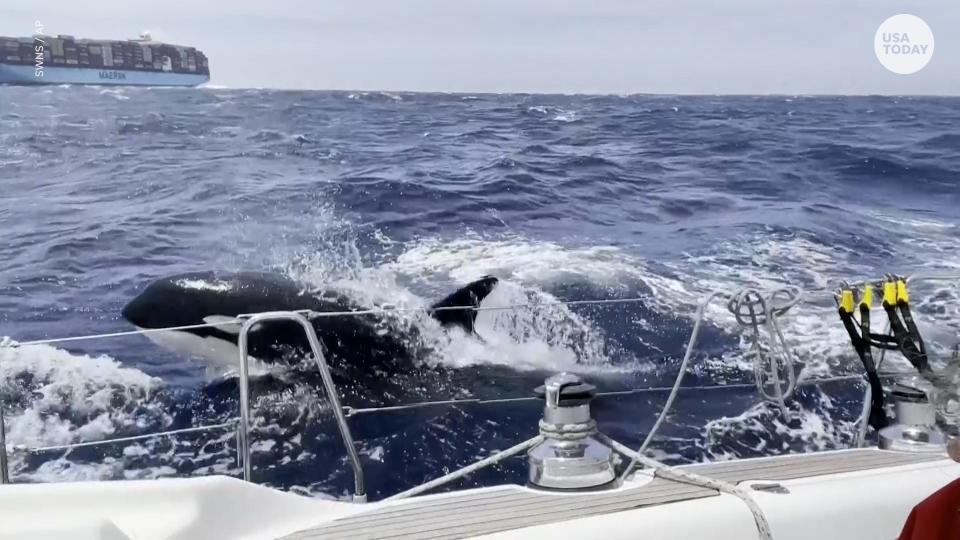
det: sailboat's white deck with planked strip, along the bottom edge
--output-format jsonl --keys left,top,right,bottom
{"left": 0, "top": 449, "right": 960, "bottom": 540}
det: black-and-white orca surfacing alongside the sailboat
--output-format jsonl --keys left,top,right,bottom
{"left": 121, "top": 271, "right": 498, "bottom": 403}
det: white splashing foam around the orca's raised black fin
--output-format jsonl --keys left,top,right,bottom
{"left": 290, "top": 237, "right": 640, "bottom": 369}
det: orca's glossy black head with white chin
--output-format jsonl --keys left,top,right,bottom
{"left": 121, "top": 272, "right": 307, "bottom": 367}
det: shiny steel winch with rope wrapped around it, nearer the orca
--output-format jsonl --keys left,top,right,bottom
{"left": 528, "top": 373, "right": 617, "bottom": 489}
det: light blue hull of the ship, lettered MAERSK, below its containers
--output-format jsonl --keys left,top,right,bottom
{"left": 0, "top": 63, "right": 210, "bottom": 86}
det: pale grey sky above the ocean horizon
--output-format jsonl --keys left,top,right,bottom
{"left": 0, "top": 0, "right": 960, "bottom": 95}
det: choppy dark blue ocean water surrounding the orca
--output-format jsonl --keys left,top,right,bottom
{"left": 0, "top": 87, "right": 960, "bottom": 498}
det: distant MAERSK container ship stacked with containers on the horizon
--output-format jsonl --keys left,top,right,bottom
{"left": 0, "top": 33, "right": 210, "bottom": 86}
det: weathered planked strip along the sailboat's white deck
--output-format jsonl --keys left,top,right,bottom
{"left": 287, "top": 449, "right": 948, "bottom": 540}
